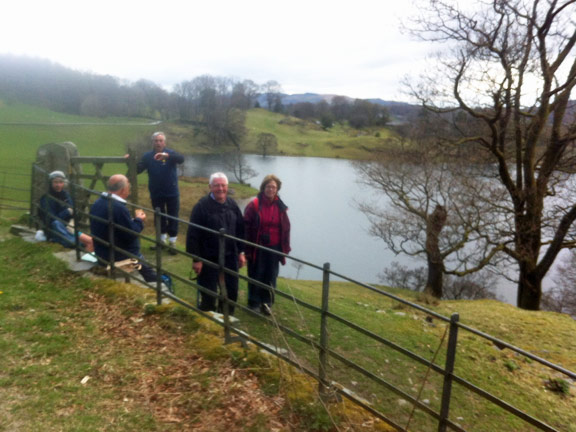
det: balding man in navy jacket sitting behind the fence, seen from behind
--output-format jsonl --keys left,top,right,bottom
{"left": 90, "top": 174, "right": 157, "bottom": 282}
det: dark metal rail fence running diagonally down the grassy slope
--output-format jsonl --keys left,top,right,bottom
{"left": 28, "top": 165, "right": 576, "bottom": 432}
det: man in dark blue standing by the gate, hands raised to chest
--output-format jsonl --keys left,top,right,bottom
{"left": 138, "top": 132, "right": 184, "bottom": 254}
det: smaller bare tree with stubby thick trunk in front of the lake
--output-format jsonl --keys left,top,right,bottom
{"left": 355, "top": 136, "right": 502, "bottom": 298}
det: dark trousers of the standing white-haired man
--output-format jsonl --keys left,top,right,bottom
{"left": 198, "top": 255, "right": 238, "bottom": 315}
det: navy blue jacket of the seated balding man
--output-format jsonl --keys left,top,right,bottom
{"left": 90, "top": 193, "right": 144, "bottom": 261}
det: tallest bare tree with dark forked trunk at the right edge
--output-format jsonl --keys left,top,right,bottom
{"left": 410, "top": 0, "right": 576, "bottom": 310}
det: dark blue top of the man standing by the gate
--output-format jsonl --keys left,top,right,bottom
{"left": 137, "top": 148, "right": 184, "bottom": 198}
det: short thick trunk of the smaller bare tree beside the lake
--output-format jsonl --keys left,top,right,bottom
{"left": 424, "top": 205, "right": 448, "bottom": 298}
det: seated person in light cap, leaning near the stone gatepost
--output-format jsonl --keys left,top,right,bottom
{"left": 38, "top": 171, "right": 94, "bottom": 252}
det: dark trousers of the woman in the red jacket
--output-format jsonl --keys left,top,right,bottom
{"left": 248, "top": 246, "right": 280, "bottom": 308}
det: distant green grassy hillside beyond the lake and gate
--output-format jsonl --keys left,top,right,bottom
{"left": 0, "top": 100, "right": 391, "bottom": 169}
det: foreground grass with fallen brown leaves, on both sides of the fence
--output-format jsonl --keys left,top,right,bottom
{"left": 0, "top": 228, "right": 576, "bottom": 432}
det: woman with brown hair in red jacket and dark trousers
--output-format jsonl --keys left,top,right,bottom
{"left": 244, "top": 174, "right": 290, "bottom": 315}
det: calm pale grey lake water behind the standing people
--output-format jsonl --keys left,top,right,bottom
{"left": 183, "top": 155, "right": 516, "bottom": 304}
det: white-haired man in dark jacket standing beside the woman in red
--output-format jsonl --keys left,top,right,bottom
{"left": 186, "top": 173, "right": 246, "bottom": 315}
